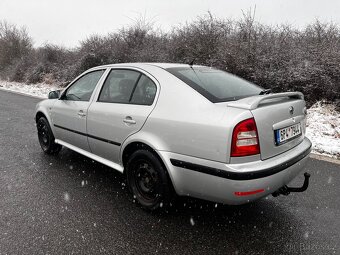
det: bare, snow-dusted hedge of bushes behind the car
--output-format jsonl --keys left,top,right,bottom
{"left": 0, "top": 13, "right": 340, "bottom": 105}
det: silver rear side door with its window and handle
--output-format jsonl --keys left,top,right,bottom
{"left": 87, "top": 69, "right": 158, "bottom": 163}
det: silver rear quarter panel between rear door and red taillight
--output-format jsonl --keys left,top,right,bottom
{"left": 133, "top": 67, "right": 252, "bottom": 163}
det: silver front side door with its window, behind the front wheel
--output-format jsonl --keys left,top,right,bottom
{"left": 51, "top": 69, "right": 105, "bottom": 151}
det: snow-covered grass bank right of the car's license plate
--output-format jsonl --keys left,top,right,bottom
{"left": 306, "top": 102, "right": 340, "bottom": 159}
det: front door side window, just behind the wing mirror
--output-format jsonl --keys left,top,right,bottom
{"left": 63, "top": 70, "right": 105, "bottom": 101}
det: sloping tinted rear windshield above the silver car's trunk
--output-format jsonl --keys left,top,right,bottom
{"left": 166, "top": 67, "right": 263, "bottom": 103}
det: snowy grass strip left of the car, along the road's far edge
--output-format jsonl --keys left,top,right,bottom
{"left": 0, "top": 80, "right": 60, "bottom": 98}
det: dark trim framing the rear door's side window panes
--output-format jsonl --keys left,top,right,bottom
{"left": 96, "top": 67, "right": 159, "bottom": 106}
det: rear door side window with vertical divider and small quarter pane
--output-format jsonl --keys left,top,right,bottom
{"left": 98, "top": 69, "right": 157, "bottom": 105}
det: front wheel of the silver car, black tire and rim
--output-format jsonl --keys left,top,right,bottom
{"left": 37, "top": 117, "right": 62, "bottom": 155}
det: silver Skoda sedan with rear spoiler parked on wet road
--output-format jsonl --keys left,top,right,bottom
{"left": 35, "top": 63, "right": 311, "bottom": 210}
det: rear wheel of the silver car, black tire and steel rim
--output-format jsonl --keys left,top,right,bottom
{"left": 126, "top": 150, "right": 174, "bottom": 211}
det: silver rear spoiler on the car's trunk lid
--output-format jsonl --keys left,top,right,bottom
{"left": 227, "top": 92, "right": 304, "bottom": 110}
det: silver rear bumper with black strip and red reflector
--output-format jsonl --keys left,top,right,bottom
{"left": 159, "top": 138, "right": 312, "bottom": 204}
